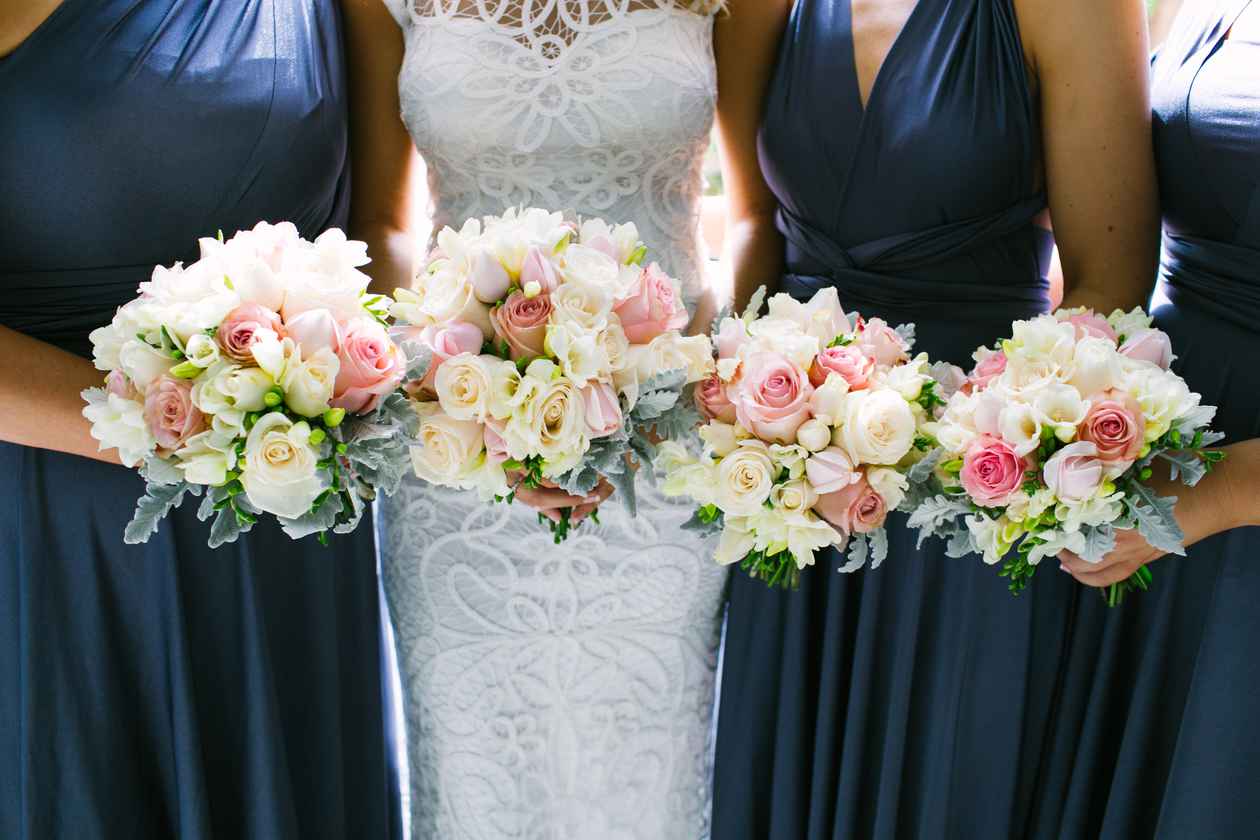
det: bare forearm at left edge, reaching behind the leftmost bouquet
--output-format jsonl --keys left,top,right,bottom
{"left": 0, "top": 327, "right": 118, "bottom": 463}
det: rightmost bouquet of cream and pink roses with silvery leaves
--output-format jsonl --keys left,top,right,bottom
{"left": 910, "top": 309, "right": 1223, "bottom": 606}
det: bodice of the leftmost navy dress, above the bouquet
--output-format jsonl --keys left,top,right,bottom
{"left": 0, "top": 0, "right": 348, "bottom": 350}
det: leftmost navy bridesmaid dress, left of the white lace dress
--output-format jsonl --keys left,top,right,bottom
{"left": 0, "top": 0, "right": 401, "bottom": 840}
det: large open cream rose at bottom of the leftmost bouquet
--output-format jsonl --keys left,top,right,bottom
{"left": 241, "top": 412, "right": 325, "bottom": 519}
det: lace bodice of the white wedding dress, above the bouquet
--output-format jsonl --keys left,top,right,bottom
{"left": 387, "top": 0, "right": 719, "bottom": 300}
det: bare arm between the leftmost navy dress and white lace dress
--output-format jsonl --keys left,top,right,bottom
{"left": 341, "top": 0, "right": 416, "bottom": 295}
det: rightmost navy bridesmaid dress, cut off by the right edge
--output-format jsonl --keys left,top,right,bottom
{"left": 1032, "top": 0, "right": 1260, "bottom": 840}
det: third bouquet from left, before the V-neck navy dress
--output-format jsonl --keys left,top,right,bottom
{"left": 658, "top": 288, "right": 942, "bottom": 588}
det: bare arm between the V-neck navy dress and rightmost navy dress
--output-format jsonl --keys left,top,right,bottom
{"left": 1016, "top": 0, "right": 1159, "bottom": 312}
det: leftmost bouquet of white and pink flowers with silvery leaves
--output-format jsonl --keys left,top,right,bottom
{"left": 83, "top": 223, "right": 423, "bottom": 548}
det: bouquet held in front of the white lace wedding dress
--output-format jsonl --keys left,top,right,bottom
{"left": 393, "top": 209, "right": 713, "bottom": 543}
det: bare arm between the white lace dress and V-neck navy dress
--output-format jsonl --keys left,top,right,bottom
{"left": 713, "top": 0, "right": 791, "bottom": 312}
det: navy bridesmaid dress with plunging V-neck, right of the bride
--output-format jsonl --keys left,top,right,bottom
{"left": 713, "top": 0, "right": 1077, "bottom": 840}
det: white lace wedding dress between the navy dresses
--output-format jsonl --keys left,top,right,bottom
{"left": 378, "top": 0, "right": 726, "bottom": 840}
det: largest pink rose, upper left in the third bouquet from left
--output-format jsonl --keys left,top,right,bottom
{"left": 728, "top": 353, "right": 814, "bottom": 443}
